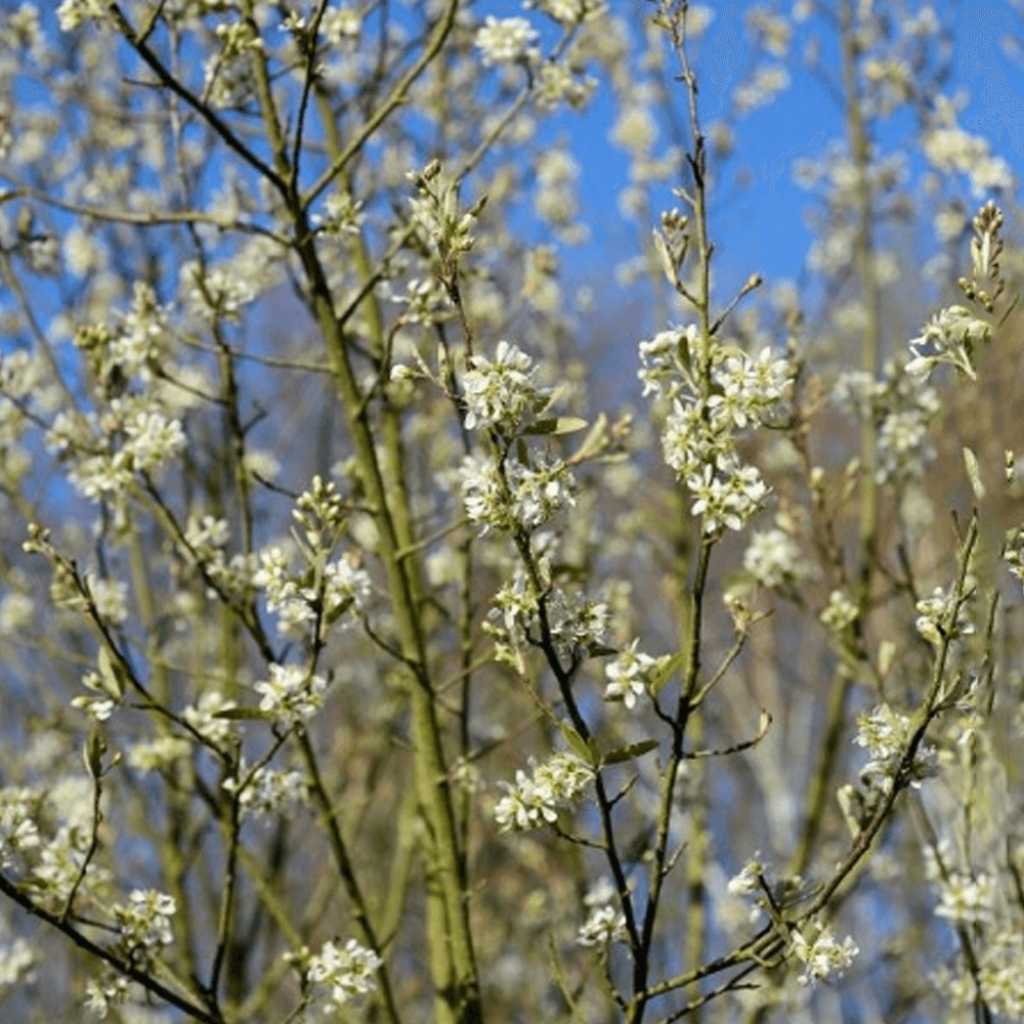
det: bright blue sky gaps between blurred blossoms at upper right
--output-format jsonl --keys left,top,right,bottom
{"left": 491, "top": 0, "right": 1024, "bottom": 315}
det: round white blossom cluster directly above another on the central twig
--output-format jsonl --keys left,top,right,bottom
{"left": 462, "top": 339, "right": 551, "bottom": 437}
